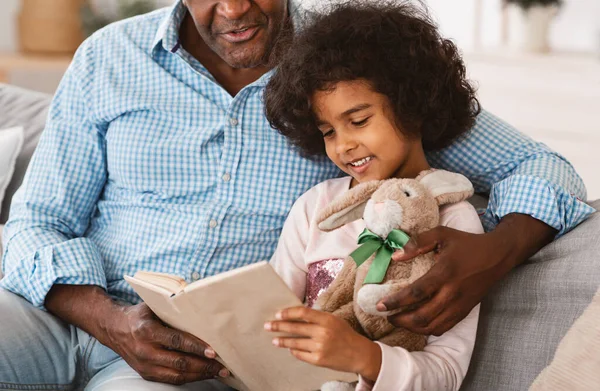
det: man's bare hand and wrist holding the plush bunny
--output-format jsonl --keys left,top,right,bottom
{"left": 377, "top": 214, "right": 557, "bottom": 336}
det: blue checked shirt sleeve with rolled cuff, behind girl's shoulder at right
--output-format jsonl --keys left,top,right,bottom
{"left": 427, "top": 111, "right": 594, "bottom": 235}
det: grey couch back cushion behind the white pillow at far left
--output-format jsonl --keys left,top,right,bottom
{"left": 0, "top": 84, "right": 52, "bottom": 224}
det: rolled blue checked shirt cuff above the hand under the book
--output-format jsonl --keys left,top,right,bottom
{"left": 0, "top": 238, "right": 106, "bottom": 310}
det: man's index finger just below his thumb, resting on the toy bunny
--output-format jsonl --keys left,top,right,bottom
{"left": 377, "top": 264, "right": 444, "bottom": 311}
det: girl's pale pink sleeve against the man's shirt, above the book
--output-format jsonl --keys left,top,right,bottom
{"left": 270, "top": 190, "right": 316, "bottom": 301}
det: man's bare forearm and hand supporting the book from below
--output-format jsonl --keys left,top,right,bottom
{"left": 45, "top": 285, "right": 229, "bottom": 385}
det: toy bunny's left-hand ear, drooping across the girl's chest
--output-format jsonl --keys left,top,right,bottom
{"left": 317, "top": 181, "right": 383, "bottom": 231}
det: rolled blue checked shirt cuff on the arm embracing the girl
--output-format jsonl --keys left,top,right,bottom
{"left": 481, "top": 175, "right": 595, "bottom": 237}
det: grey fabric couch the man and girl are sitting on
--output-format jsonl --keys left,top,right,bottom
{"left": 0, "top": 85, "right": 600, "bottom": 391}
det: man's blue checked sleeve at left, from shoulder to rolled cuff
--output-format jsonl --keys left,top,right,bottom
{"left": 0, "top": 37, "right": 106, "bottom": 308}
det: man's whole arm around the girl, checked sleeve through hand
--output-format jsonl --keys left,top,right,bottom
{"left": 379, "top": 111, "right": 594, "bottom": 335}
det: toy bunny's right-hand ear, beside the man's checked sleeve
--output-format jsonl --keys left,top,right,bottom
{"left": 416, "top": 170, "right": 473, "bottom": 205}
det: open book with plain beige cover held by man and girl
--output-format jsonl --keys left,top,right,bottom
{"left": 125, "top": 262, "right": 357, "bottom": 391}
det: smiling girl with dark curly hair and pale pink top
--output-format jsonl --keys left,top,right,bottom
{"left": 265, "top": 3, "right": 483, "bottom": 391}
